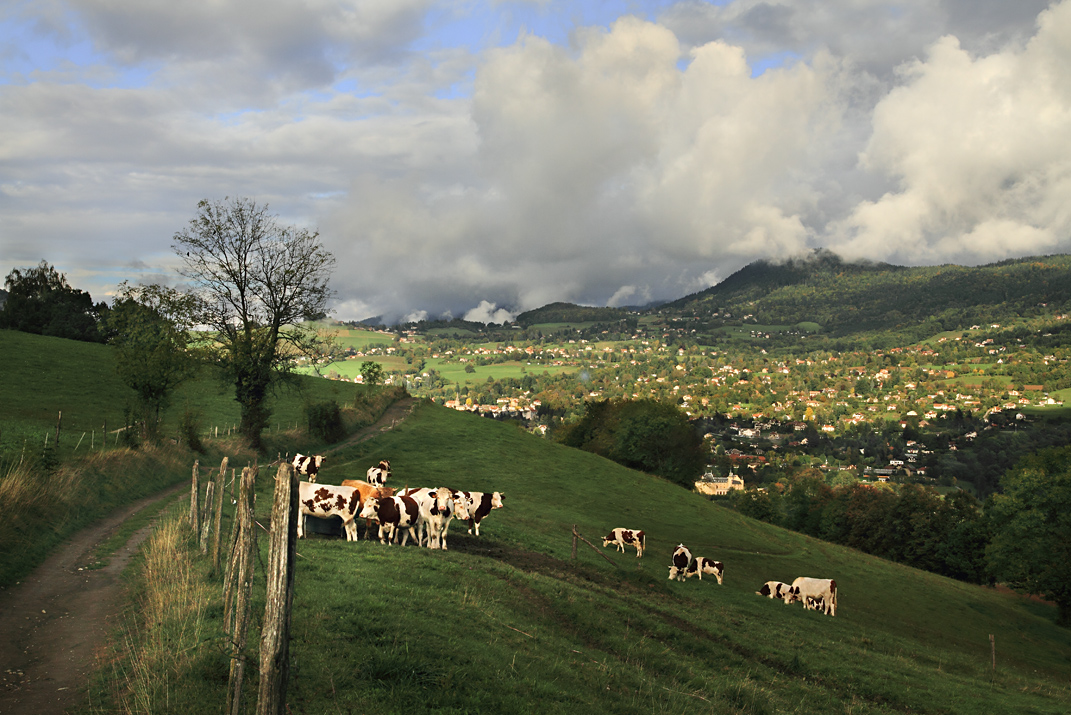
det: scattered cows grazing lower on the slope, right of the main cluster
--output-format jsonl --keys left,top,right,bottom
{"left": 603, "top": 528, "right": 836, "bottom": 615}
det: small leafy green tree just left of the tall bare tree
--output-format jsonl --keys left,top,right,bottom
{"left": 106, "top": 283, "right": 197, "bottom": 439}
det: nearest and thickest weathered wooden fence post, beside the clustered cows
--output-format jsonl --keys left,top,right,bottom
{"left": 257, "top": 463, "right": 299, "bottom": 715}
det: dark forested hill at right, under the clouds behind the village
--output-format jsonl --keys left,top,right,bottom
{"left": 661, "top": 252, "right": 1071, "bottom": 336}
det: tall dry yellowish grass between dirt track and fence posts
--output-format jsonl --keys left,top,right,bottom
{"left": 103, "top": 516, "right": 215, "bottom": 715}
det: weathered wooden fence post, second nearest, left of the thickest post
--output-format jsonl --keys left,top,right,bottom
{"left": 224, "top": 467, "right": 257, "bottom": 715}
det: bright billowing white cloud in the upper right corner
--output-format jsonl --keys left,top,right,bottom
{"left": 831, "top": 2, "right": 1071, "bottom": 263}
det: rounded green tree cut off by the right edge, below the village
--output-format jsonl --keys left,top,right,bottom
{"left": 985, "top": 447, "right": 1071, "bottom": 626}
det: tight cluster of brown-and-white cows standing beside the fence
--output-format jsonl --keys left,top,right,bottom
{"left": 290, "top": 454, "right": 502, "bottom": 549}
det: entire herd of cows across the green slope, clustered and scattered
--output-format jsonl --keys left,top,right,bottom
{"left": 291, "top": 454, "right": 836, "bottom": 615}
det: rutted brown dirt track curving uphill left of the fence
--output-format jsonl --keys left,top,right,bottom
{"left": 0, "top": 398, "right": 418, "bottom": 715}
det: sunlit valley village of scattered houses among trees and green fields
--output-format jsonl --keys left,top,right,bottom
{"left": 302, "top": 315, "right": 1071, "bottom": 496}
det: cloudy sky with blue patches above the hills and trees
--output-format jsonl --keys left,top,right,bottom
{"left": 0, "top": 0, "right": 1071, "bottom": 322}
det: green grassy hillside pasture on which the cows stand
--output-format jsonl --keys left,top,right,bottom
{"left": 265, "top": 405, "right": 1071, "bottom": 713}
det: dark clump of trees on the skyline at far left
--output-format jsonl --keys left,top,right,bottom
{"left": 0, "top": 260, "right": 107, "bottom": 343}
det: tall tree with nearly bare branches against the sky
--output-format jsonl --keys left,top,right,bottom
{"left": 171, "top": 198, "right": 334, "bottom": 446}
